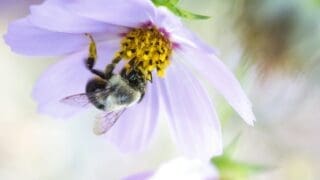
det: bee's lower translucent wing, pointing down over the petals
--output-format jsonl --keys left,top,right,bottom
{"left": 93, "top": 108, "right": 126, "bottom": 135}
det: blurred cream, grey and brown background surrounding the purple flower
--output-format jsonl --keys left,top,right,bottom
{"left": 0, "top": 0, "right": 320, "bottom": 180}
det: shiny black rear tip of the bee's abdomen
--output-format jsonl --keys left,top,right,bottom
{"left": 86, "top": 79, "right": 107, "bottom": 110}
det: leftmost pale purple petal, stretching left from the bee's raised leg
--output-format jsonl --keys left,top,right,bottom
{"left": 4, "top": 18, "right": 88, "bottom": 56}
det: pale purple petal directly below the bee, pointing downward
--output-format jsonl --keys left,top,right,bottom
{"left": 107, "top": 79, "right": 159, "bottom": 152}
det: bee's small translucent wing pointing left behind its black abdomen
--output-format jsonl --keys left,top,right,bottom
{"left": 60, "top": 93, "right": 90, "bottom": 107}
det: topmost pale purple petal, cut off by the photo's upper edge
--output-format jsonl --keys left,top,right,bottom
{"left": 66, "top": 0, "right": 155, "bottom": 27}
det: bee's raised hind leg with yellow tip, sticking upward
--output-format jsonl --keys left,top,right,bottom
{"left": 85, "top": 33, "right": 105, "bottom": 79}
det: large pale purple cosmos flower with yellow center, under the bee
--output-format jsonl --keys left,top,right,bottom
{"left": 5, "top": 0, "right": 255, "bottom": 159}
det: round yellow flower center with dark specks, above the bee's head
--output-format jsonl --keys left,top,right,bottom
{"left": 115, "top": 26, "right": 172, "bottom": 80}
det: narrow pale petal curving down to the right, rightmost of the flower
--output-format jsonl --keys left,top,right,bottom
{"left": 177, "top": 46, "right": 255, "bottom": 125}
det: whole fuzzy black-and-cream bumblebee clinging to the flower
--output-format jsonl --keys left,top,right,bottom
{"left": 62, "top": 34, "right": 148, "bottom": 135}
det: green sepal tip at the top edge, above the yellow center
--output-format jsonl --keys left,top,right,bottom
{"left": 152, "top": 0, "right": 210, "bottom": 19}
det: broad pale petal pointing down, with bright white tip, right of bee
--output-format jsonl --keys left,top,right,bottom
{"left": 159, "top": 57, "right": 222, "bottom": 160}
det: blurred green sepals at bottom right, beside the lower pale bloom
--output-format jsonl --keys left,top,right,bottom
{"left": 211, "top": 135, "right": 270, "bottom": 180}
